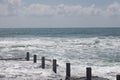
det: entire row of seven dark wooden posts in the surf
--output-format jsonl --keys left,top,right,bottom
{"left": 26, "top": 52, "right": 120, "bottom": 80}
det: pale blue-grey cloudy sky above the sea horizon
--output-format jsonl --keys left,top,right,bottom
{"left": 0, "top": 0, "right": 120, "bottom": 28}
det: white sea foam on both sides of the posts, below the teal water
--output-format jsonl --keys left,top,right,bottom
{"left": 0, "top": 37, "right": 120, "bottom": 80}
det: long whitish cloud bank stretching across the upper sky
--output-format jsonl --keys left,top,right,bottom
{"left": 0, "top": 0, "right": 120, "bottom": 16}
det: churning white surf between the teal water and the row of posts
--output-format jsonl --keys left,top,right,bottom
{"left": 0, "top": 37, "right": 120, "bottom": 80}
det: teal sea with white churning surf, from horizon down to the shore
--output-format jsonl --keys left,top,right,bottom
{"left": 0, "top": 27, "right": 120, "bottom": 80}
